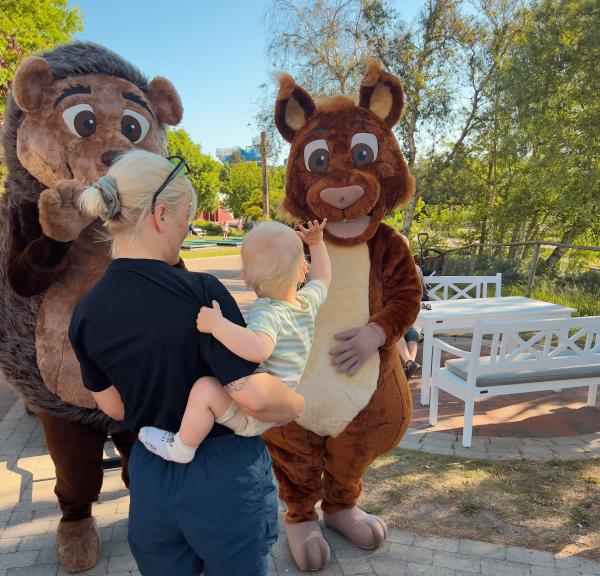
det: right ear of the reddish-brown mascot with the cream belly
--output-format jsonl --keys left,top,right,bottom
{"left": 359, "top": 58, "right": 404, "bottom": 128}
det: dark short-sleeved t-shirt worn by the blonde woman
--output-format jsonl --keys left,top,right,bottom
{"left": 69, "top": 258, "right": 257, "bottom": 437}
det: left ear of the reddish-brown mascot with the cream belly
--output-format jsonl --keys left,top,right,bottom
{"left": 275, "top": 74, "right": 316, "bottom": 142}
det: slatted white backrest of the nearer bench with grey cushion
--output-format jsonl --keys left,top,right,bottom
{"left": 468, "top": 316, "right": 600, "bottom": 376}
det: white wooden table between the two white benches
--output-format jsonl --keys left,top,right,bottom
{"left": 415, "top": 296, "right": 577, "bottom": 406}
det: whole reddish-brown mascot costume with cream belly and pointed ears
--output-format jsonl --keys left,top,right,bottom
{"left": 264, "top": 59, "right": 421, "bottom": 570}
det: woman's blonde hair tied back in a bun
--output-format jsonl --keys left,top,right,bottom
{"left": 79, "top": 150, "right": 198, "bottom": 235}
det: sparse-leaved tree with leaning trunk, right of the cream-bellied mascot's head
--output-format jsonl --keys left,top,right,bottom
{"left": 364, "top": 0, "right": 523, "bottom": 235}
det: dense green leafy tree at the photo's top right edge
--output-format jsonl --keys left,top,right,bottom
{"left": 503, "top": 0, "right": 600, "bottom": 267}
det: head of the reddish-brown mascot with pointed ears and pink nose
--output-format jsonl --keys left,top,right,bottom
{"left": 275, "top": 58, "right": 415, "bottom": 246}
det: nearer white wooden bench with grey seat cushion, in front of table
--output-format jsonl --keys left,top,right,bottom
{"left": 429, "top": 316, "right": 600, "bottom": 447}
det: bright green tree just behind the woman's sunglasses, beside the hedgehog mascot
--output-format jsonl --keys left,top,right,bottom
{"left": 167, "top": 128, "right": 221, "bottom": 212}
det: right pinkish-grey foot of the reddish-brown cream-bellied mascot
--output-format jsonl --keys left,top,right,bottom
{"left": 323, "top": 506, "right": 387, "bottom": 550}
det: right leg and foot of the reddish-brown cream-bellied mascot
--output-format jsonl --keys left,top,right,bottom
{"left": 321, "top": 361, "right": 412, "bottom": 549}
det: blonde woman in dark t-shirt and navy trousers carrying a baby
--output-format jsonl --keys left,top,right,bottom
{"left": 69, "top": 150, "right": 304, "bottom": 576}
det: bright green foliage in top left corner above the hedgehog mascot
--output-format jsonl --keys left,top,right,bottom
{"left": 0, "top": 0, "right": 83, "bottom": 120}
